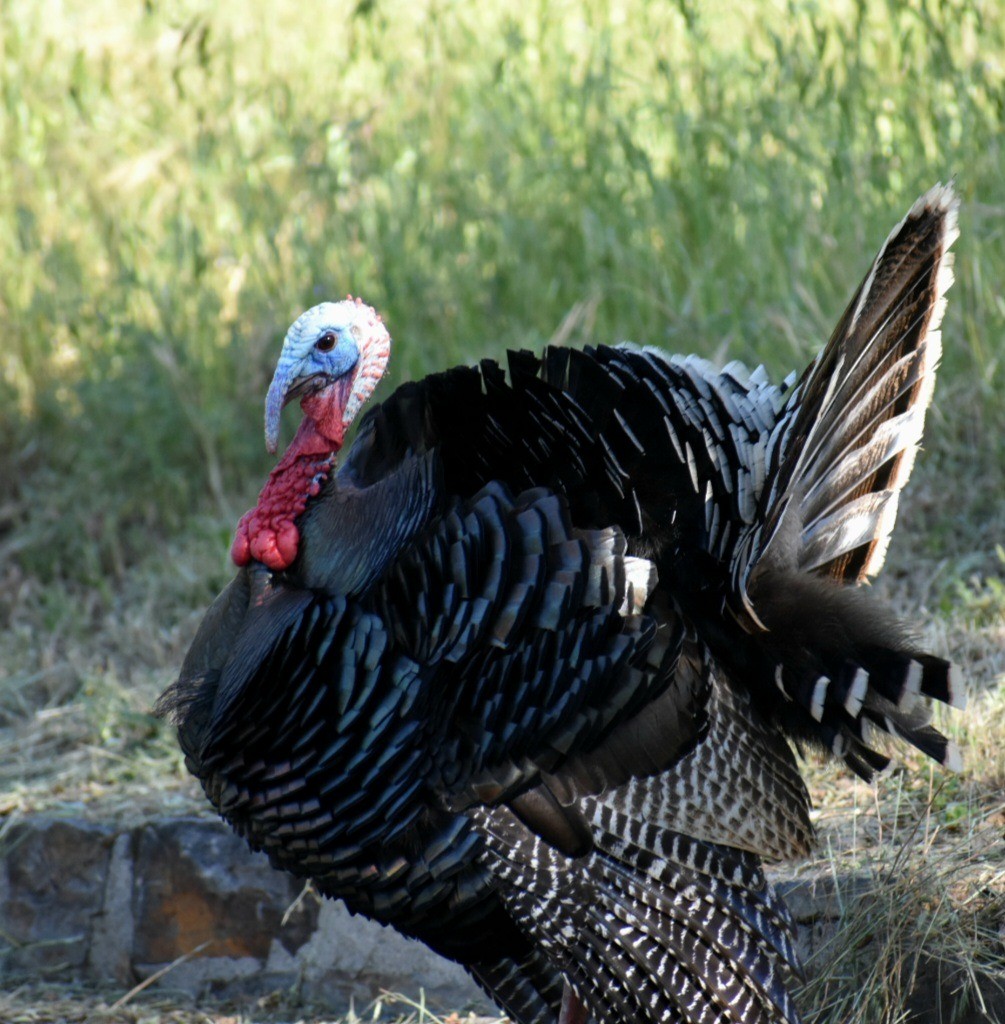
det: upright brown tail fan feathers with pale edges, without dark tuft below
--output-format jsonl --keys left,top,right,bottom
{"left": 735, "top": 185, "right": 959, "bottom": 593}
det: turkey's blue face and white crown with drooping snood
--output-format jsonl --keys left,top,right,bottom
{"left": 265, "top": 299, "right": 370, "bottom": 453}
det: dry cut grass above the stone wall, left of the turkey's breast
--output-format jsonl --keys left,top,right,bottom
{"left": 0, "top": 522, "right": 227, "bottom": 815}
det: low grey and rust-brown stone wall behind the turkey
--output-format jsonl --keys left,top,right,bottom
{"left": 0, "top": 816, "right": 1005, "bottom": 1022}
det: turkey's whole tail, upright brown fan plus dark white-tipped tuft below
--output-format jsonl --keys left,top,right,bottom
{"left": 731, "top": 185, "right": 964, "bottom": 779}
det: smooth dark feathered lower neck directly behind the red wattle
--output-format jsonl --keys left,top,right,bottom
{"left": 290, "top": 454, "right": 439, "bottom": 594}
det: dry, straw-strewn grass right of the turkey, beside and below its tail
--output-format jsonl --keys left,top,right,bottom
{"left": 782, "top": 544, "right": 1005, "bottom": 1024}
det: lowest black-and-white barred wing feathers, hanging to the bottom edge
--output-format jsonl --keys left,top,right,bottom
{"left": 475, "top": 798, "right": 798, "bottom": 1024}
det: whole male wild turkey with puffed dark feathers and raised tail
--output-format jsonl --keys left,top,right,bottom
{"left": 159, "top": 186, "right": 961, "bottom": 1024}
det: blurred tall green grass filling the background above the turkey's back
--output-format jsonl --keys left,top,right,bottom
{"left": 0, "top": 0, "right": 1005, "bottom": 582}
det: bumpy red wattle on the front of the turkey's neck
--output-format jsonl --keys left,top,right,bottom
{"left": 231, "top": 410, "right": 344, "bottom": 572}
